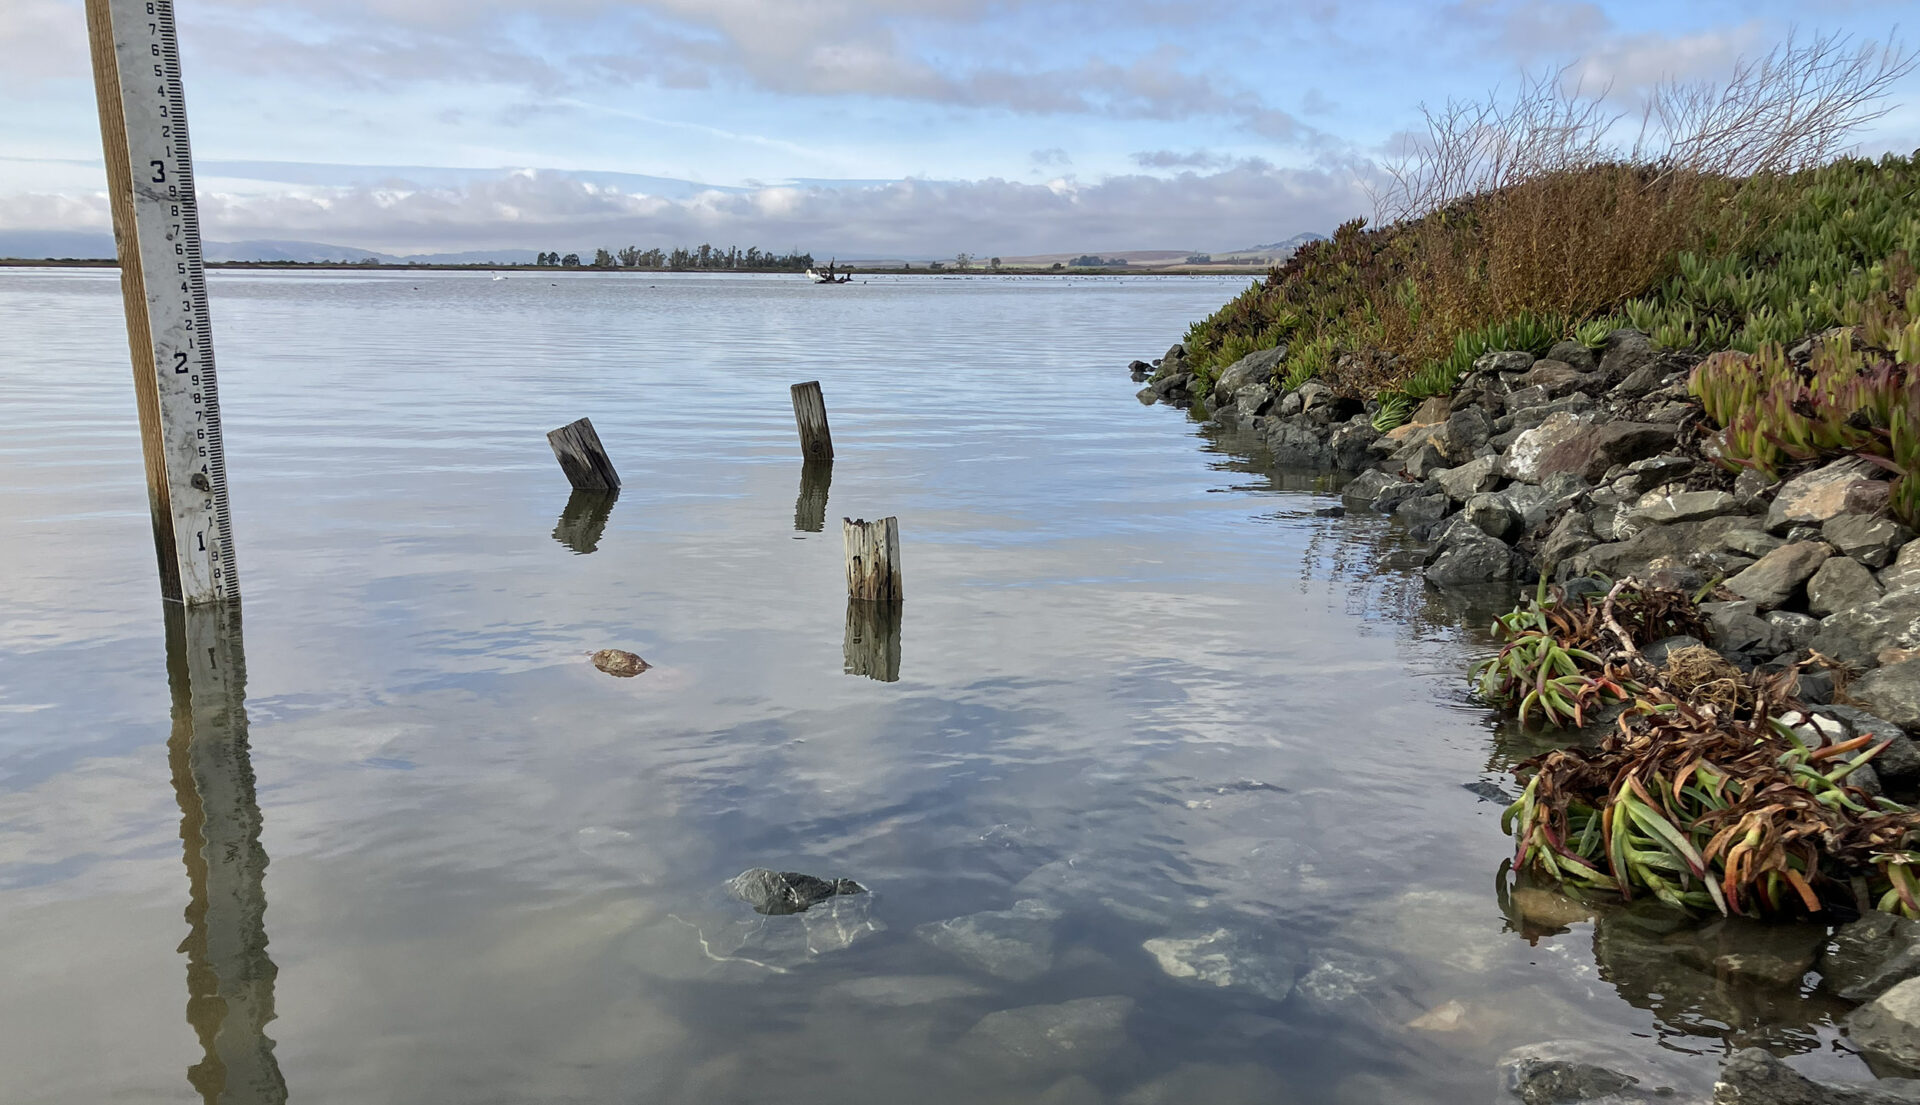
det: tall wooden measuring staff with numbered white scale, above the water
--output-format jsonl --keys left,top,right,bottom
{"left": 86, "top": 0, "right": 240, "bottom": 606}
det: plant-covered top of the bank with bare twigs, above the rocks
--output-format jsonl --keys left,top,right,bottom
{"left": 1187, "top": 38, "right": 1920, "bottom": 420}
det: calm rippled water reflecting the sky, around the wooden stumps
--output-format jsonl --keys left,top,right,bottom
{"left": 0, "top": 270, "right": 1857, "bottom": 1105}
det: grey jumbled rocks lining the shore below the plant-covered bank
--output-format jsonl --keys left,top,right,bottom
{"left": 1129, "top": 330, "right": 1920, "bottom": 1105}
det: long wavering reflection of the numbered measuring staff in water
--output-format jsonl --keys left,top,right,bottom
{"left": 165, "top": 602, "right": 286, "bottom": 1105}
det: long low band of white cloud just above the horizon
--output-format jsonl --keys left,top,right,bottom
{"left": 0, "top": 161, "right": 1365, "bottom": 257}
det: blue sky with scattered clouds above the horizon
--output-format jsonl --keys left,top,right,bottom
{"left": 0, "top": 0, "right": 1920, "bottom": 257}
